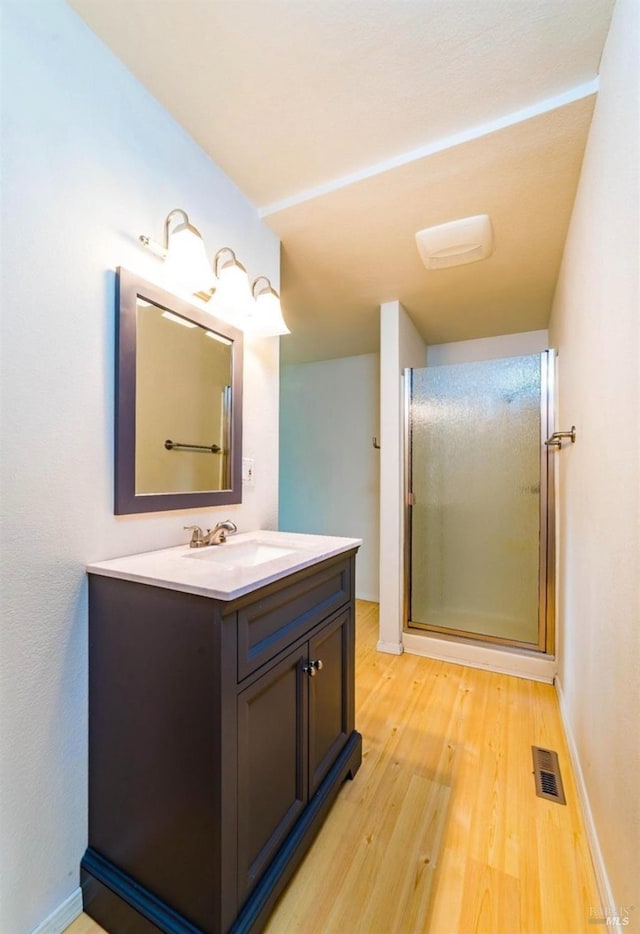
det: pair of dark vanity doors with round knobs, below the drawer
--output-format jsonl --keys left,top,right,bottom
{"left": 238, "top": 608, "right": 353, "bottom": 895}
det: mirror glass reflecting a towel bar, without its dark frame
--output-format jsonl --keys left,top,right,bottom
{"left": 136, "top": 306, "right": 233, "bottom": 495}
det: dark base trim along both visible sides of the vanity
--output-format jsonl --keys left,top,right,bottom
{"left": 81, "top": 730, "right": 362, "bottom": 934}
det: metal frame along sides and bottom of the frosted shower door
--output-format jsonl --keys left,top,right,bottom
{"left": 403, "top": 349, "right": 557, "bottom": 656}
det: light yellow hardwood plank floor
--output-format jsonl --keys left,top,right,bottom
{"left": 67, "top": 601, "right": 600, "bottom": 934}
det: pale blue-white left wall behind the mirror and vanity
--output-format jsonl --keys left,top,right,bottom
{"left": 0, "top": 0, "right": 279, "bottom": 934}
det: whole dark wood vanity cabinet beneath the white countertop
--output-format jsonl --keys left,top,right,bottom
{"left": 82, "top": 551, "right": 362, "bottom": 934}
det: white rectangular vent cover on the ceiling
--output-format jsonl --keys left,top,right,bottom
{"left": 416, "top": 214, "right": 493, "bottom": 269}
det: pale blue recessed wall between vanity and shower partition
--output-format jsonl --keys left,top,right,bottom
{"left": 279, "top": 354, "right": 380, "bottom": 600}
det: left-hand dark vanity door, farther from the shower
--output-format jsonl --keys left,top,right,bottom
{"left": 238, "top": 644, "right": 309, "bottom": 903}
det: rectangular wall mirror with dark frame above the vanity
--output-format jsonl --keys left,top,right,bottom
{"left": 115, "top": 268, "right": 243, "bottom": 515}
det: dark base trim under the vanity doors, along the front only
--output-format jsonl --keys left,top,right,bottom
{"left": 229, "top": 730, "right": 362, "bottom": 934}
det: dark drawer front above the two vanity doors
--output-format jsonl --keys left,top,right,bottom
{"left": 238, "top": 559, "right": 351, "bottom": 681}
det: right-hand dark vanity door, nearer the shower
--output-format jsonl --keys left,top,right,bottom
{"left": 308, "top": 609, "right": 354, "bottom": 798}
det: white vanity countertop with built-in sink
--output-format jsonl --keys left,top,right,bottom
{"left": 87, "top": 530, "right": 362, "bottom": 600}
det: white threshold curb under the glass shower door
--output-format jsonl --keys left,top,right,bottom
{"left": 402, "top": 632, "right": 558, "bottom": 684}
